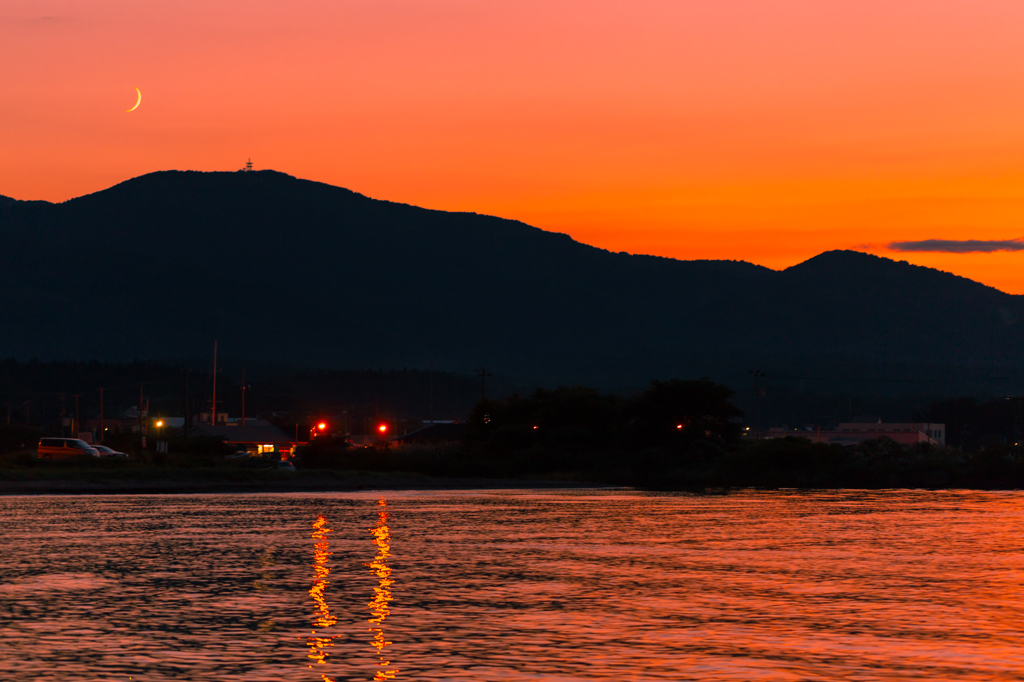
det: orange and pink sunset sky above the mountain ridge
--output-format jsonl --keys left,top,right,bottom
{"left": 0, "top": 0, "right": 1024, "bottom": 294}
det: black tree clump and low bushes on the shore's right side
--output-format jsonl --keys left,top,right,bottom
{"left": 302, "top": 380, "right": 1024, "bottom": 489}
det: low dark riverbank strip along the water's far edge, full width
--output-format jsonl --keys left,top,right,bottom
{"left": 8, "top": 438, "right": 1024, "bottom": 495}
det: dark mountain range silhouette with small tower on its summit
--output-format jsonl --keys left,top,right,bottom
{"left": 0, "top": 171, "right": 1024, "bottom": 386}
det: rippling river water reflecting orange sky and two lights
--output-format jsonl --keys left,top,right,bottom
{"left": 0, "top": 491, "right": 1024, "bottom": 682}
